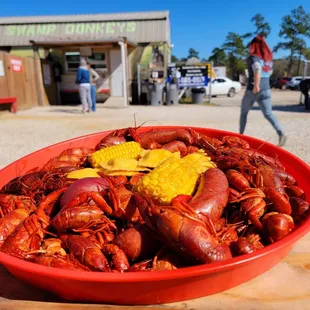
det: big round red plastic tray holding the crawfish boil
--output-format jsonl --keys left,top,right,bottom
{"left": 0, "top": 126, "right": 310, "bottom": 305}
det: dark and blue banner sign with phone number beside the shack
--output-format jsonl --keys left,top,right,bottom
{"left": 168, "top": 64, "right": 210, "bottom": 88}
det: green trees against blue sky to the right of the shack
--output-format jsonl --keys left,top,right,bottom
{"left": 171, "top": 6, "right": 310, "bottom": 79}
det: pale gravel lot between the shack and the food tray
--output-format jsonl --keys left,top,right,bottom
{"left": 0, "top": 92, "right": 310, "bottom": 169}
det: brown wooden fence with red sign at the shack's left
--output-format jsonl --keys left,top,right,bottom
{"left": 0, "top": 52, "right": 48, "bottom": 110}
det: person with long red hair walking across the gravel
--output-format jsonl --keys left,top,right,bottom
{"left": 240, "top": 35, "right": 287, "bottom": 146}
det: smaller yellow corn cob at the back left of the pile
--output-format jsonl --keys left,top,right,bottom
{"left": 88, "top": 142, "right": 142, "bottom": 168}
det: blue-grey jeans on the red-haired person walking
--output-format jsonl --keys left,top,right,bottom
{"left": 240, "top": 89, "right": 283, "bottom": 136}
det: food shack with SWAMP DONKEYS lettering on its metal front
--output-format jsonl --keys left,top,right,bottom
{"left": 0, "top": 11, "right": 170, "bottom": 106}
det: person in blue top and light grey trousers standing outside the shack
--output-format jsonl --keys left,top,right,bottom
{"left": 76, "top": 58, "right": 92, "bottom": 113}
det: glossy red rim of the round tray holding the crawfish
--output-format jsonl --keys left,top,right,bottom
{"left": 0, "top": 126, "right": 310, "bottom": 283}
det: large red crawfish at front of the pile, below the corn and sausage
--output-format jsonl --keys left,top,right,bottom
{"left": 135, "top": 195, "right": 232, "bottom": 264}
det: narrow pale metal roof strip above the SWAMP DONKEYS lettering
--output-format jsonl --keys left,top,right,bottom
{"left": 0, "top": 11, "right": 169, "bottom": 25}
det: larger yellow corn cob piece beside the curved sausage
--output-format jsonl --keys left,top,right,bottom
{"left": 135, "top": 156, "right": 199, "bottom": 205}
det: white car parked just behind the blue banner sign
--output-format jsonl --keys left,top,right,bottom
{"left": 205, "top": 77, "right": 241, "bottom": 97}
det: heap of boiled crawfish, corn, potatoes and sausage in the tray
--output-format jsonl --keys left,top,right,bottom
{"left": 0, "top": 128, "right": 309, "bottom": 272}
